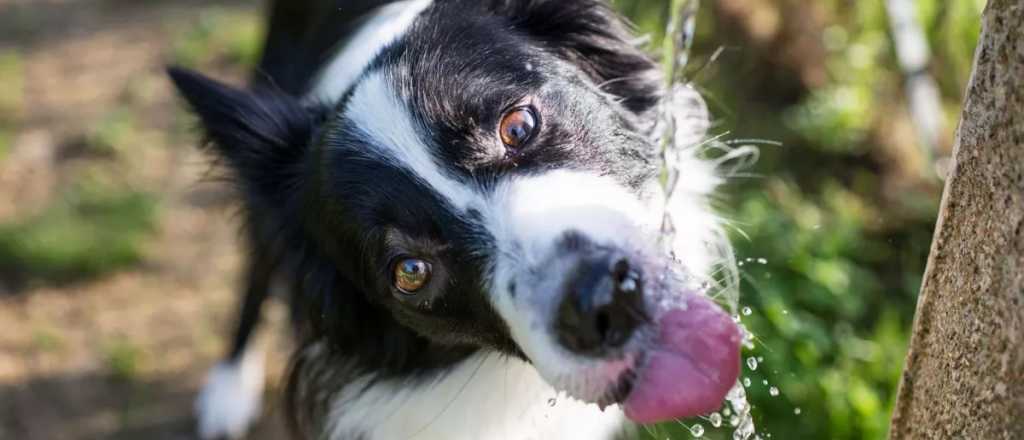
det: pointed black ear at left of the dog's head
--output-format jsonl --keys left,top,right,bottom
{"left": 168, "top": 68, "right": 324, "bottom": 193}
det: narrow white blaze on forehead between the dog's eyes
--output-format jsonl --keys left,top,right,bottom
{"left": 344, "top": 71, "right": 481, "bottom": 211}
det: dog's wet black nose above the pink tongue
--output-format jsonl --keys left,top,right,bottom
{"left": 555, "top": 254, "right": 646, "bottom": 356}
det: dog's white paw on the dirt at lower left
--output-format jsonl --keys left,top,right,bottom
{"left": 196, "top": 348, "right": 265, "bottom": 439}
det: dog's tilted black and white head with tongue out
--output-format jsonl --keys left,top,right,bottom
{"left": 172, "top": 0, "right": 740, "bottom": 422}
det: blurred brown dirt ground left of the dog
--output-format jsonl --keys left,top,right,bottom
{"left": 0, "top": 0, "right": 287, "bottom": 440}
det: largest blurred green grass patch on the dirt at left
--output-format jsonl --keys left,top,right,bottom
{"left": 0, "top": 186, "right": 156, "bottom": 282}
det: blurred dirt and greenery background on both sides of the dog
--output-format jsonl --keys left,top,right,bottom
{"left": 0, "top": 0, "right": 984, "bottom": 440}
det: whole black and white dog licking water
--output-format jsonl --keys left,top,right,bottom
{"left": 170, "top": 0, "right": 741, "bottom": 440}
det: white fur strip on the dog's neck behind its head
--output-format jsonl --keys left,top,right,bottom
{"left": 310, "top": 0, "right": 431, "bottom": 102}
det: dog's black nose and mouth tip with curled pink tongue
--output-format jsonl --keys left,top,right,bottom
{"left": 553, "top": 231, "right": 741, "bottom": 423}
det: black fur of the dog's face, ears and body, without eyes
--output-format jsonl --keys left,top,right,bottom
{"left": 170, "top": 0, "right": 660, "bottom": 438}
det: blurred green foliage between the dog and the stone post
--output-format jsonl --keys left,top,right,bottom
{"left": 614, "top": 0, "right": 984, "bottom": 440}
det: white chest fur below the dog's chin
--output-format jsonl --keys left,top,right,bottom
{"left": 328, "top": 353, "right": 624, "bottom": 440}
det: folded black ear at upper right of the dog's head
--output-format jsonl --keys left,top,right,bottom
{"left": 496, "top": 0, "right": 663, "bottom": 115}
